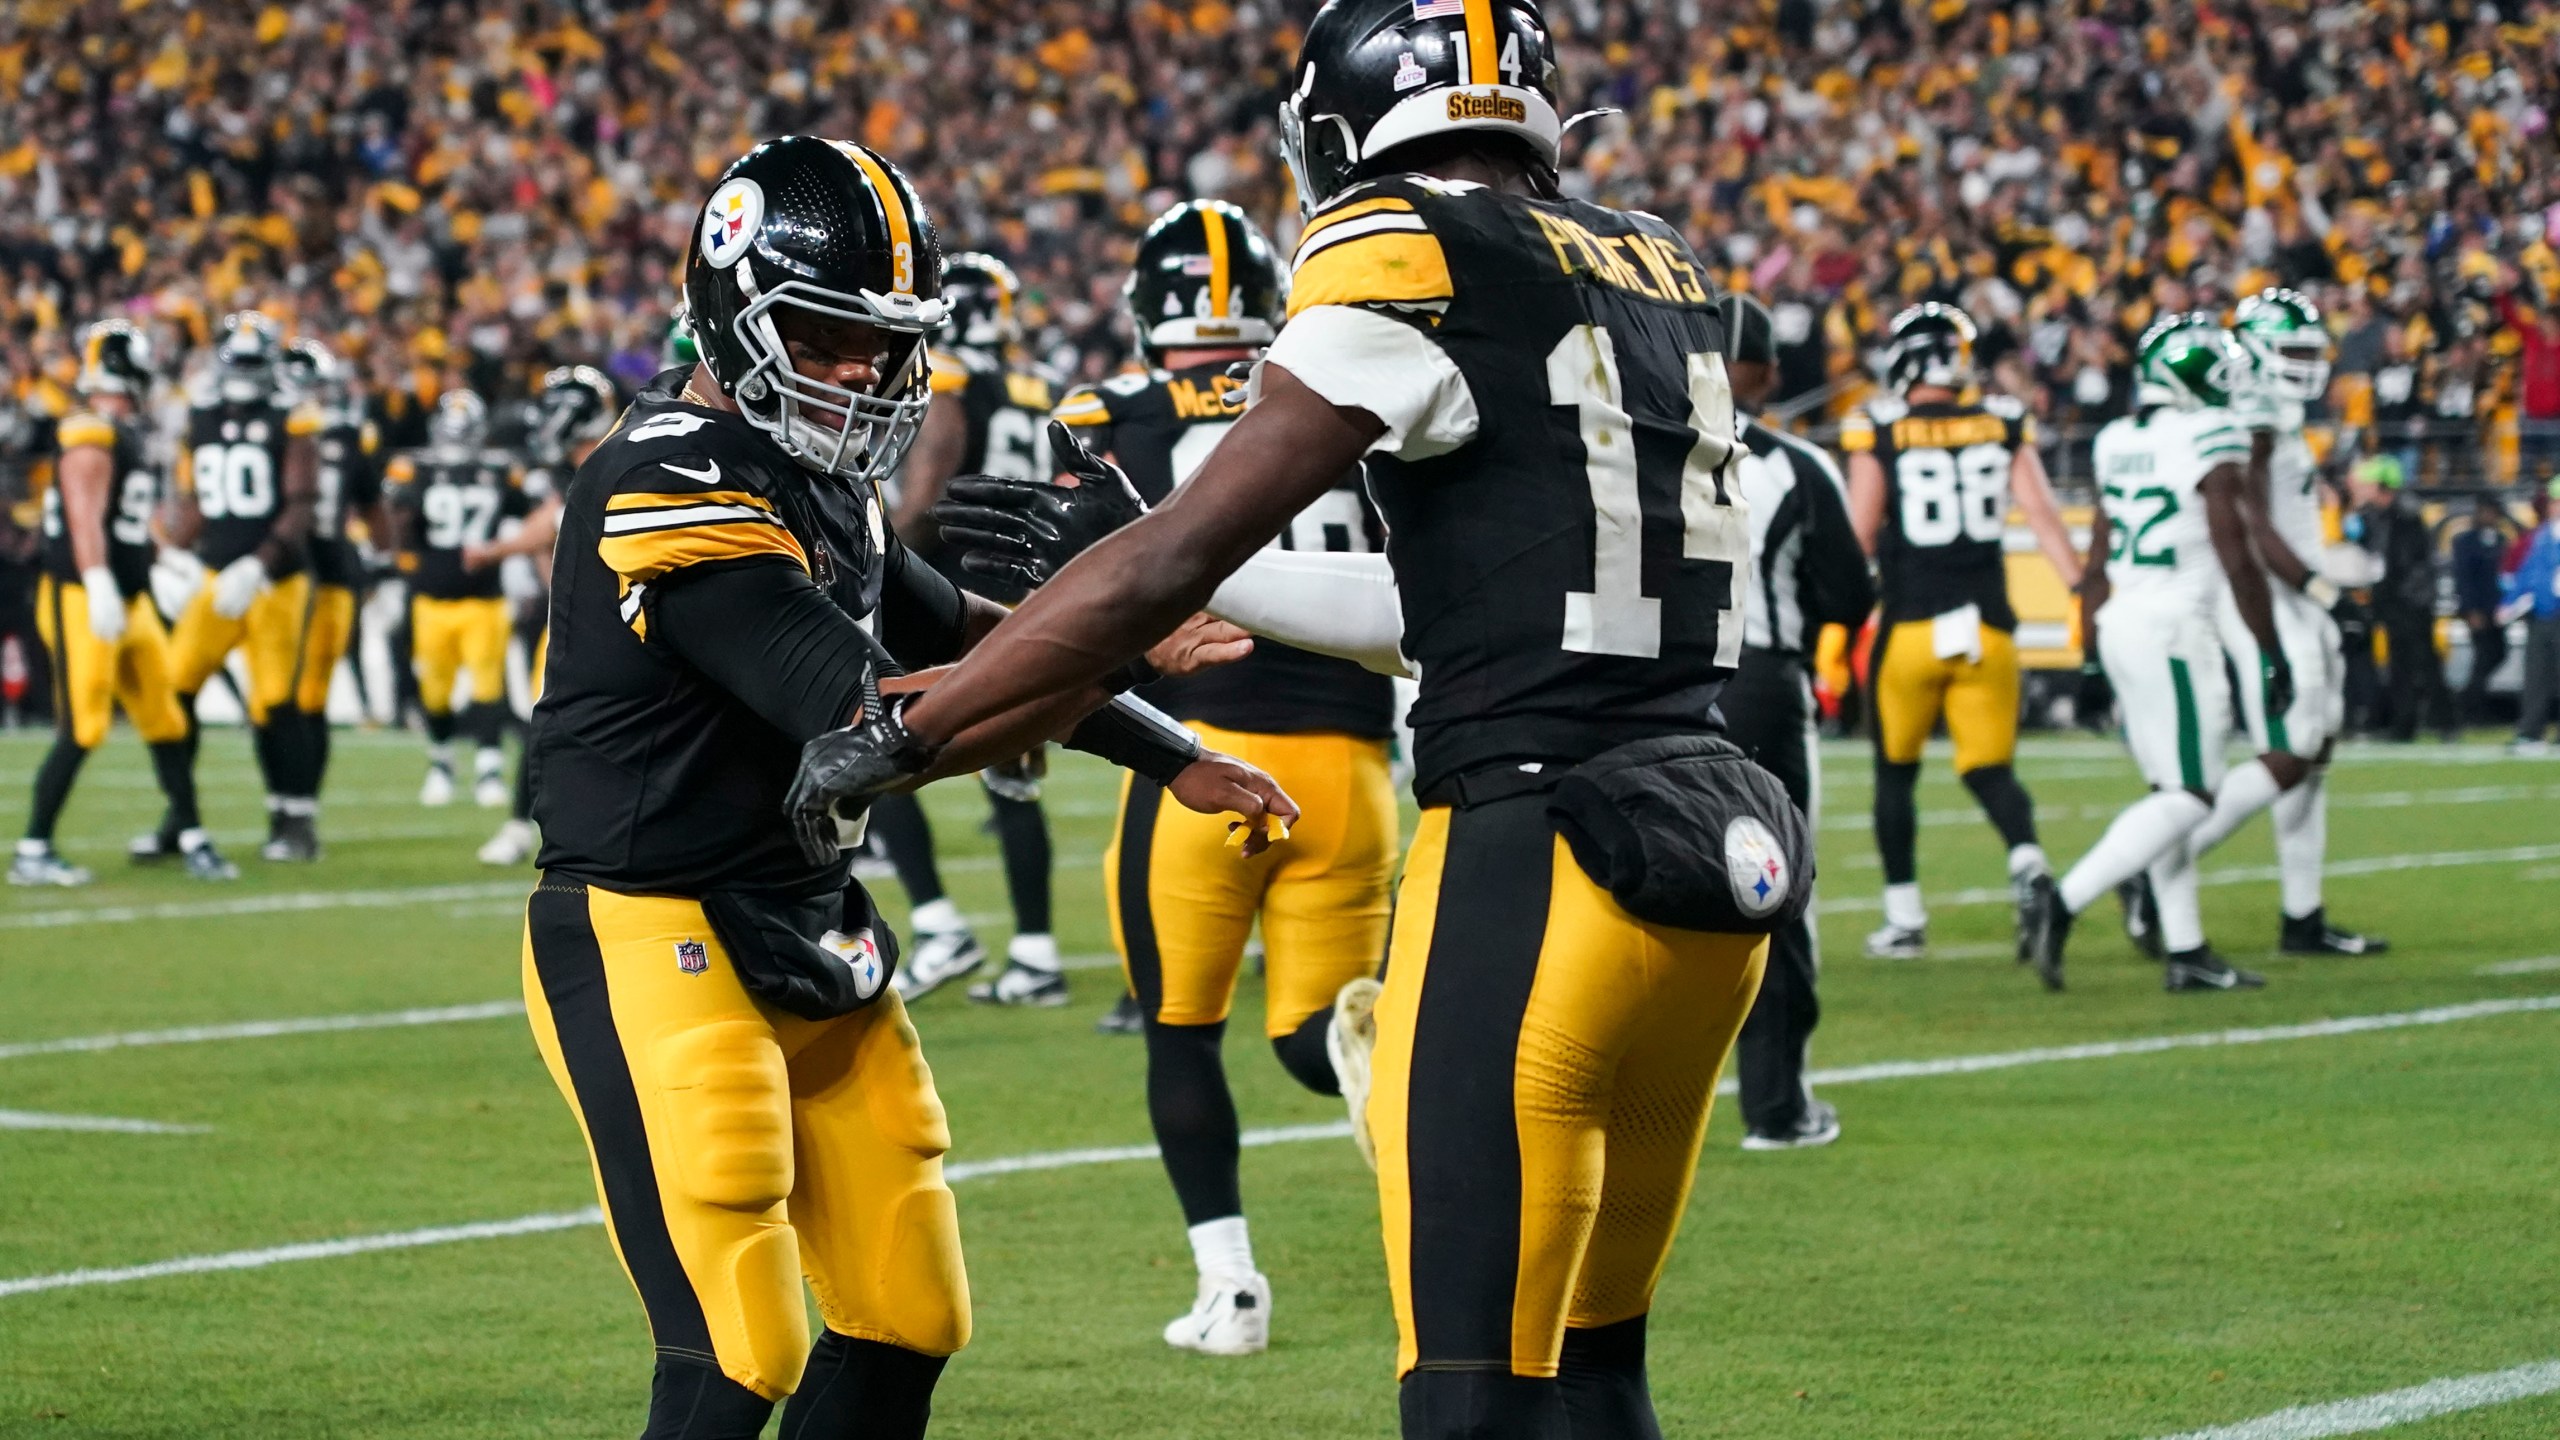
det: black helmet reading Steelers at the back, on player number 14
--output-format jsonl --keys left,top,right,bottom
{"left": 1280, "top": 0, "right": 1564, "bottom": 213}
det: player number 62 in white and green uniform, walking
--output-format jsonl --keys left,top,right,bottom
{"left": 2022, "top": 313, "right": 2294, "bottom": 992}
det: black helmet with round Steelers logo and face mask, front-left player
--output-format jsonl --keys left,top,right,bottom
{"left": 684, "top": 136, "right": 950, "bottom": 482}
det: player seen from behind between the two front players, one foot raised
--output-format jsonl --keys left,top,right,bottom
{"left": 1057, "top": 200, "right": 1398, "bottom": 1355}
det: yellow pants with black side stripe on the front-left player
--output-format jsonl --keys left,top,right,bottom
{"left": 525, "top": 876, "right": 970, "bottom": 1399}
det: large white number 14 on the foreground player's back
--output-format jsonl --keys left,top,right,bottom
{"left": 1546, "top": 325, "right": 1751, "bottom": 666}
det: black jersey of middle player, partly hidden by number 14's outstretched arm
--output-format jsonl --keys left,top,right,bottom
{"left": 1057, "top": 364, "right": 1395, "bottom": 740}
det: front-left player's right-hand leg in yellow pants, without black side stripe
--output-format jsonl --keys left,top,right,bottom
{"left": 781, "top": 992, "right": 970, "bottom": 1440}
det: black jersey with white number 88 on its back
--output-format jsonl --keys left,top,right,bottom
{"left": 1841, "top": 395, "right": 2035, "bottom": 630}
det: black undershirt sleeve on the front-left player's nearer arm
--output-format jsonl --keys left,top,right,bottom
{"left": 648, "top": 556, "right": 886, "bottom": 740}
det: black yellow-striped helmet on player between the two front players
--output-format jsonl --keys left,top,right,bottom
{"left": 1121, "top": 200, "right": 1285, "bottom": 364}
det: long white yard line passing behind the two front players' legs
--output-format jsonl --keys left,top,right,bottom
{"left": 0, "top": 994, "right": 2560, "bottom": 1301}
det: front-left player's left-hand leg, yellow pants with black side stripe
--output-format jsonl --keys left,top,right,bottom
{"left": 525, "top": 881, "right": 819, "bottom": 1440}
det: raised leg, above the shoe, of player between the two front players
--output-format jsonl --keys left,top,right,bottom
{"left": 1254, "top": 733, "right": 1398, "bottom": 1094}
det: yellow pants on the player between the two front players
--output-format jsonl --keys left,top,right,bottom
{"left": 1103, "top": 725, "right": 1395, "bottom": 1040}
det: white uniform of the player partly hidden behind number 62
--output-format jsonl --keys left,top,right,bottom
{"left": 2214, "top": 397, "right": 2348, "bottom": 758}
